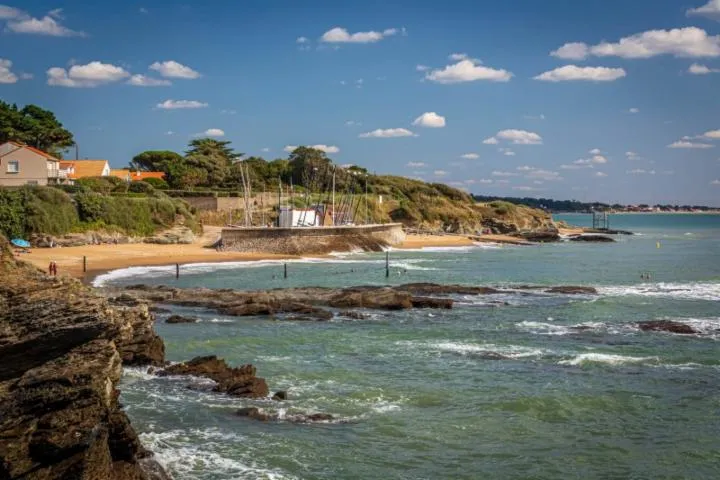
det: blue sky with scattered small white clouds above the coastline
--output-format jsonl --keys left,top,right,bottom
{"left": 0, "top": 0, "right": 720, "bottom": 206}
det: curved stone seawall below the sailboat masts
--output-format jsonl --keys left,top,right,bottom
{"left": 222, "top": 223, "right": 405, "bottom": 255}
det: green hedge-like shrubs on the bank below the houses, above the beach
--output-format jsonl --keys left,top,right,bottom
{"left": 0, "top": 182, "right": 200, "bottom": 238}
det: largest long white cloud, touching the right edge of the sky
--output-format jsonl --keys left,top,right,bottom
{"left": 551, "top": 27, "right": 720, "bottom": 60}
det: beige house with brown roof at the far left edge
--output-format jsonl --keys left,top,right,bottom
{"left": 0, "top": 142, "right": 65, "bottom": 187}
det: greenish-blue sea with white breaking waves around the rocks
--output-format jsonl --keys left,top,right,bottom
{"left": 96, "top": 214, "right": 720, "bottom": 480}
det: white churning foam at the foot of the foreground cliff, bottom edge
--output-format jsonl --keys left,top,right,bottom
{"left": 140, "top": 428, "right": 296, "bottom": 480}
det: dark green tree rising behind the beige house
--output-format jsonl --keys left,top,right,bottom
{"left": 0, "top": 101, "right": 75, "bottom": 157}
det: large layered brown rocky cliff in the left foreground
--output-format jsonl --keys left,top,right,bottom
{"left": 0, "top": 238, "right": 169, "bottom": 480}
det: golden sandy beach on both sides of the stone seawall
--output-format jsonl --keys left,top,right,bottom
{"left": 18, "top": 226, "right": 523, "bottom": 281}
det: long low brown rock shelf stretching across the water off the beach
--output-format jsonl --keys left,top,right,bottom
{"left": 108, "top": 283, "right": 597, "bottom": 320}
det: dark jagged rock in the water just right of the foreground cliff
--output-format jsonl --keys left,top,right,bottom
{"left": 157, "top": 355, "right": 269, "bottom": 398}
